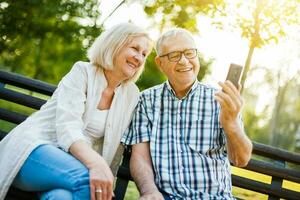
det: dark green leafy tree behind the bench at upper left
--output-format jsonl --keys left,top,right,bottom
{"left": 0, "top": 0, "right": 102, "bottom": 83}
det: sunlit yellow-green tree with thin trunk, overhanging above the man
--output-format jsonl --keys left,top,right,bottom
{"left": 139, "top": 0, "right": 300, "bottom": 92}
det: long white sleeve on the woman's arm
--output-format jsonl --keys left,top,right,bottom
{"left": 56, "top": 62, "right": 89, "bottom": 152}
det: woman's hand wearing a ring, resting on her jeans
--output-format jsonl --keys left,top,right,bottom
{"left": 89, "top": 157, "right": 114, "bottom": 200}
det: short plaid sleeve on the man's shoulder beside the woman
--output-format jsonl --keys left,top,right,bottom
{"left": 121, "top": 95, "right": 152, "bottom": 145}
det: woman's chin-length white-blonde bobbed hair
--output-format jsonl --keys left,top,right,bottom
{"left": 87, "top": 23, "right": 151, "bottom": 82}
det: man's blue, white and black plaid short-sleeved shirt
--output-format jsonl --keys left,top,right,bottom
{"left": 122, "top": 81, "right": 233, "bottom": 199}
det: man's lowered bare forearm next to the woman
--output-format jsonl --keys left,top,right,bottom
{"left": 130, "top": 142, "right": 163, "bottom": 200}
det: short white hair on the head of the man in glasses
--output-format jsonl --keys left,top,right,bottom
{"left": 155, "top": 28, "right": 195, "bottom": 56}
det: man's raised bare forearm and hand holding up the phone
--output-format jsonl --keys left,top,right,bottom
{"left": 215, "top": 81, "right": 252, "bottom": 167}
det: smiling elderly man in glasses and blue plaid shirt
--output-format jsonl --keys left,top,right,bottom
{"left": 122, "top": 29, "right": 252, "bottom": 200}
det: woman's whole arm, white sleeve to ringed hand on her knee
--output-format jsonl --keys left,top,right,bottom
{"left": 56, "top": 62, "right": 114, "bottom": 200}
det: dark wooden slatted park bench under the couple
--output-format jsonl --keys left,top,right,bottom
{"left": 0, "top": 71, "right": 300, "bottom": 200}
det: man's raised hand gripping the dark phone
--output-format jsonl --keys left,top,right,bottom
{"left": 215, "top": 81, "right": 243, "bottom": 130}
